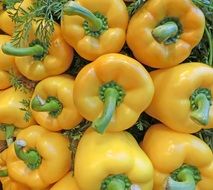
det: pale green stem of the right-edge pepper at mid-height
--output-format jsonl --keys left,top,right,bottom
{"left": 190, "top": 93, "right": 211, "bottom": 125}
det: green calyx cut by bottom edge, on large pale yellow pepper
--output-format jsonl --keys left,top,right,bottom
{"left": 100, "top": 174, "right": 132, "bottom": 190}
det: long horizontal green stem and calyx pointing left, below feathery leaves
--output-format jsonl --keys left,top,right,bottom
{"left": 1, "top": 40, "right": 46, "bottom": 60}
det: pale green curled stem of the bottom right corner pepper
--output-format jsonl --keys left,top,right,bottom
{"left": 167, "top": 169, "right": 196, "bottom": 190}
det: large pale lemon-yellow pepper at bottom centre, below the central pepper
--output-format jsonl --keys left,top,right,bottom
{"left": 74, "top": 129, "right": 153, "bottom": 190}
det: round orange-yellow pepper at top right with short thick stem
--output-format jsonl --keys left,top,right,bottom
{"left": 126, "top": 0, "right": 205, "bottom": 68}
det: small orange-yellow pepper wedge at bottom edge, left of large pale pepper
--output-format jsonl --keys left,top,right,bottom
{"left": 50, "top": 172, "right": 80, "bottom": 190}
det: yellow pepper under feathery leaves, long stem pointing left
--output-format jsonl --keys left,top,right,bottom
{"left": 2, "top": 23, "right": 73, "bottom": 81}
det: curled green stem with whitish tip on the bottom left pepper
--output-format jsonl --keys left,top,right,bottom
{"left": 14, "top": 140, "right": 41, "bottom": 170}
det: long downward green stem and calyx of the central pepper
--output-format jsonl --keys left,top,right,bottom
{"left": 92, "top": 81, "right": 125, "bottom": 134}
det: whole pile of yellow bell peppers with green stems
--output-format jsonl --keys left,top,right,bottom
{"left": 0, "top": 0, "right": 213, "bottom": 190}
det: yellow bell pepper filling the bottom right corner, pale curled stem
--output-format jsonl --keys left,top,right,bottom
{"left": 140, "top": 124, "right": 213, "bottom": 190}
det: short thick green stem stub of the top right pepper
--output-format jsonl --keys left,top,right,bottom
{"left": 152, "top": 21, "right": 178, "bottom": 43}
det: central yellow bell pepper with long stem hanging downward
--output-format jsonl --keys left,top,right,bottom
{"left": 74, "top": 53, "right": 154, "bottom": 133}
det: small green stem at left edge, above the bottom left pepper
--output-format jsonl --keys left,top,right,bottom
{"left": 0, "top": 123, "right": 15, "bottom": 146}
